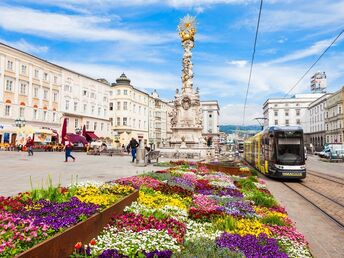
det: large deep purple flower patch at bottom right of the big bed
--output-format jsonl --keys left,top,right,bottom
{"left": 216, "top": 233, "right": 288, "bottom": 258}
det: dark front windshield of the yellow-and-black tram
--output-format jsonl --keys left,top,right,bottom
{"left": 277, "top": 137, "right": 304, "bottom": 165}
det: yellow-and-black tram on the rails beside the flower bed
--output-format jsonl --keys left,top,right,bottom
{"left": 244, "top": 126, "right": 306, "bottom": 179}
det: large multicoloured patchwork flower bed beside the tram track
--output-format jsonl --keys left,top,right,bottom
{"left": 72, "top": 162, "right": 312, "bottom": 258}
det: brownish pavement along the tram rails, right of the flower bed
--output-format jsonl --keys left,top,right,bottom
{"left": 262, "top": 175, "right": 344, "bottom": 258}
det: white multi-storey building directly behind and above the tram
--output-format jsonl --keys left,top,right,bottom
{"left": 263, "top": 93, "right": 323, "bottom": 133}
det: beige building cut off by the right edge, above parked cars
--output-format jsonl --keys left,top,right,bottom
{"left": 325, "top": 87, "right": 344, "bottom": 143}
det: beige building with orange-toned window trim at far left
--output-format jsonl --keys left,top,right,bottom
{"left": 0, "top": 43, "right": 61, "bottom": 143}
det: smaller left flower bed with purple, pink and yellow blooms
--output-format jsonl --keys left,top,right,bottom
{"left": 0, "top": 183, "right": 135, "bottom": 257}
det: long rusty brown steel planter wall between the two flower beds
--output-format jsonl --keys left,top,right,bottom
{"left": 16, "top": 191, "right": 139, "bottom": 258}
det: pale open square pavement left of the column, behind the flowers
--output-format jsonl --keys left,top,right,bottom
{"left": 0, "top": 151, "right": 161, "bottom": 196}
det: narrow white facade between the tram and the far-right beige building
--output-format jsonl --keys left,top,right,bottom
{"left": 305, "top": 93, "right": 331, "bottom": 151}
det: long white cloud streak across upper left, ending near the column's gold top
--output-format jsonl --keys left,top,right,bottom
{"left": 0, "top": 5, "right": 177, "bottom": 44}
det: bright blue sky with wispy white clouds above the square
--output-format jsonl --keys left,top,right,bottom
{"left": 0, "top": 0, "right": 344, "bottom": 124}
